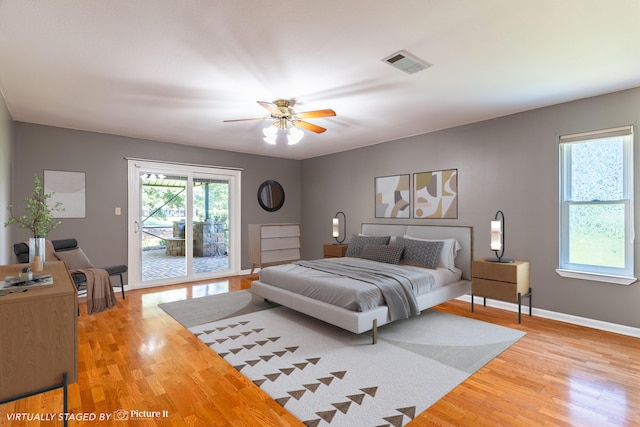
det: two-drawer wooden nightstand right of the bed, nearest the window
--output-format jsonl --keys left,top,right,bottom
{"left": 471, "top": 259, "right": 532, "bottom": 323}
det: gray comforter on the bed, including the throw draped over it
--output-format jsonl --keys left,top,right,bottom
{"left": 260, "top": 258, "right": 435, "bottom": 320}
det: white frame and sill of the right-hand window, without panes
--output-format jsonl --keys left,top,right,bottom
{"left": 556, "top": 126, "right": 637, "bottom": 285}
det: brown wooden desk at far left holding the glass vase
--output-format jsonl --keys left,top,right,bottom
{"left": 0, "top": 261, "right": 78, "bottom": 403}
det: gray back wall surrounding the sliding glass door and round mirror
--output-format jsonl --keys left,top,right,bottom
{"left": 9, "top": 122, "right": 301, "bottom": 268}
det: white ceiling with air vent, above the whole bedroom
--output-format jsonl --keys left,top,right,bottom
{"left": 0, "top": 0, "right": 640, "bottom": 159}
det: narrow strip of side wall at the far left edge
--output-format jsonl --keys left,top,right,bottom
{"left": 0, "top": 92, "right": 13, "bottom": 265}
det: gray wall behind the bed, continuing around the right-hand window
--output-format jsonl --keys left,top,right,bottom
{"left": 302, "top": 89, "right": 640, "bottom": 327}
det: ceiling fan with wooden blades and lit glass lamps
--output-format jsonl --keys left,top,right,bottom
{"left": 224, "top": 99, "right": 336, "bottom": 145}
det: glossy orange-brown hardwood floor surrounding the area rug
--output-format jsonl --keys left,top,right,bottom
{"left": 0, "top": 276, "right": 640, "bottom": 427}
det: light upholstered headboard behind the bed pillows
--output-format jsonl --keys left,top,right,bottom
{"left": 361, "top": 223, "right": 473, "bottom": 280}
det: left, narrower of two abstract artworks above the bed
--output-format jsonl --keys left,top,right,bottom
{"left": 375, "top": 174, "right": 411, "bottom": 218}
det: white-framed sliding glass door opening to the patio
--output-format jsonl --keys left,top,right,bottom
{"left": 129, "top": 160, "right": 240, "bottom": 288}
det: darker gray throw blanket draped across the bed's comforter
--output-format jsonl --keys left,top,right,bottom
{"left": 294, "top": 259, "right": 420, "bottom": 321}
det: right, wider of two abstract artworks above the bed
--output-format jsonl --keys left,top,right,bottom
{"left": 413, "top": 169, "right": 458, "bottom": 218}
